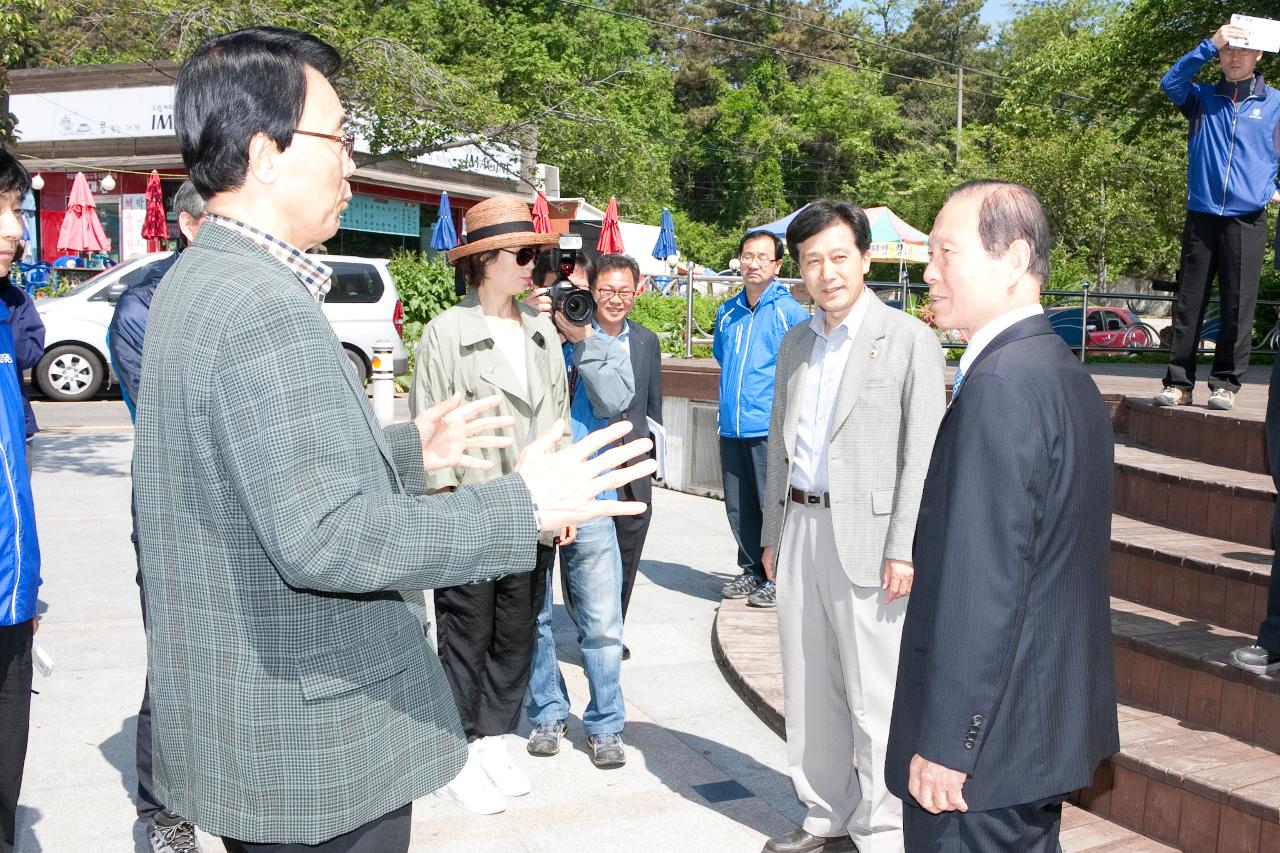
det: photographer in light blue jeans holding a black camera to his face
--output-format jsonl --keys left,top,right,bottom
{"left": 526, "top": 244, "right": 635, "bottom": 767}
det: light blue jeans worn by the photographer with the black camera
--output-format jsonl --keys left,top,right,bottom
{"left": 525, "top": 519, "right": 626, "bottom": 735}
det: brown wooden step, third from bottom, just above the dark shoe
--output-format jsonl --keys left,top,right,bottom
{"left": 1111, "top": 515, "right": 1272, "bottom": 634}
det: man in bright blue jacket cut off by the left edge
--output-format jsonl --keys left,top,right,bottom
{"left": 0, "top": 150, "right": 40, "bottom": 853}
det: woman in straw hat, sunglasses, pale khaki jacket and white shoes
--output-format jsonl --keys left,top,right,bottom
{"left": 410, "top": 197, "right": 568, "bottom": 815}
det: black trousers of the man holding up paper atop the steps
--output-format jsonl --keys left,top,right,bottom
{"left": 1165, "top": 209, "right": 1267, "bottom": 392}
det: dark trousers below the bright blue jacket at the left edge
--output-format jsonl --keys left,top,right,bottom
{"left": 0, "top": 619, "right": 32, "bottom": 853}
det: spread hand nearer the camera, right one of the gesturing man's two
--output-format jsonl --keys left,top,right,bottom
{"left": 516, "top": 420, "right": 658, "bottom": 530}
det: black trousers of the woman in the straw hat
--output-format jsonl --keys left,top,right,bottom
{"left": 435, "top": 544, "right": 556, "bottom": 740}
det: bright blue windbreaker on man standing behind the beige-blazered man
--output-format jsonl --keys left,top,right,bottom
{"left": 712, "top": 282, "right": 809, "bottom": 438}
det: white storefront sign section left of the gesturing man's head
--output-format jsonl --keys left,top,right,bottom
{"left": 9, "top": 86, "right": 174, "bottom": 142}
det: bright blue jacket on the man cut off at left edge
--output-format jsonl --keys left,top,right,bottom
{"left": 0, "top": 302, "right": 40, "bottom": 625}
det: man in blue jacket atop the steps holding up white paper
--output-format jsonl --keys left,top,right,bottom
{"left": 1152, "top": 24, "right": 1280, "bottom": 411}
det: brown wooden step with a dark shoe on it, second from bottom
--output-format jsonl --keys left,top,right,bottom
{"left": 1111, "top": 598, "right": 1280, "bottom": 747}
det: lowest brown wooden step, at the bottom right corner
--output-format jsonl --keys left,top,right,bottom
{"left": 1075, "top": 703, "right": 1280, "bottom": 853}
